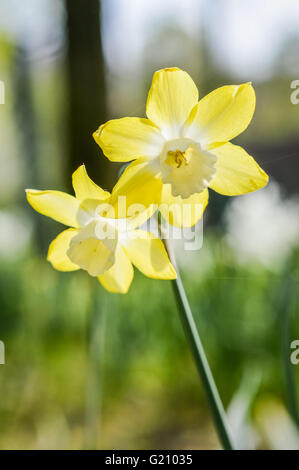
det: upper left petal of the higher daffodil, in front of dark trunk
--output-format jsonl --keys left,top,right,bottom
{"left": 93, "top": 117, "right": 164, "bottom": 162}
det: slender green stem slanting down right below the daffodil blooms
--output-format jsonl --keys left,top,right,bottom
{"left": 163, "top": 240, "right": 234, "bottom": 450}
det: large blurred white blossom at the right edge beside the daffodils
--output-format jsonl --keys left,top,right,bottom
{"left": 225, "top": 182, "right": 299, "bottom": 267}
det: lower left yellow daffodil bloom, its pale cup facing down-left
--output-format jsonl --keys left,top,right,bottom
{"left": 26, "top": 165, "right": 176, "bottom": 293}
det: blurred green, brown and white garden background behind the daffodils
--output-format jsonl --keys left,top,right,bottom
{"left": 0, "top": 0, "right": 299, "bottom": 449}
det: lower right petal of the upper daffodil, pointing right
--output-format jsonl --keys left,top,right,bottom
{"left": 210, "top": 142, "right": 269, "bottom": 196}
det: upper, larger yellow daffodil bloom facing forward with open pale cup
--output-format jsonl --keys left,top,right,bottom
{"left": 93, "top": 68, "right": 268, "bottom": 226}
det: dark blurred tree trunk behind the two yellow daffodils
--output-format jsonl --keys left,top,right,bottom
{"left": 66, "top": 0, "right": 116, "bottom": 189}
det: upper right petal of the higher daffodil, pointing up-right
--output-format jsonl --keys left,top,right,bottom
{"left": 183, "top": 83, "right": 255, "bottom": 146}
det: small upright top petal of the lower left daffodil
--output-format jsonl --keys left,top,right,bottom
{"left": 73, "top": 165, "right": 110, "bottom": 201}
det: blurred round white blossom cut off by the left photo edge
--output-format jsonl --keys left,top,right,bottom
{"left": 0, "top": 210, "right": 32, "bottom": 259}
